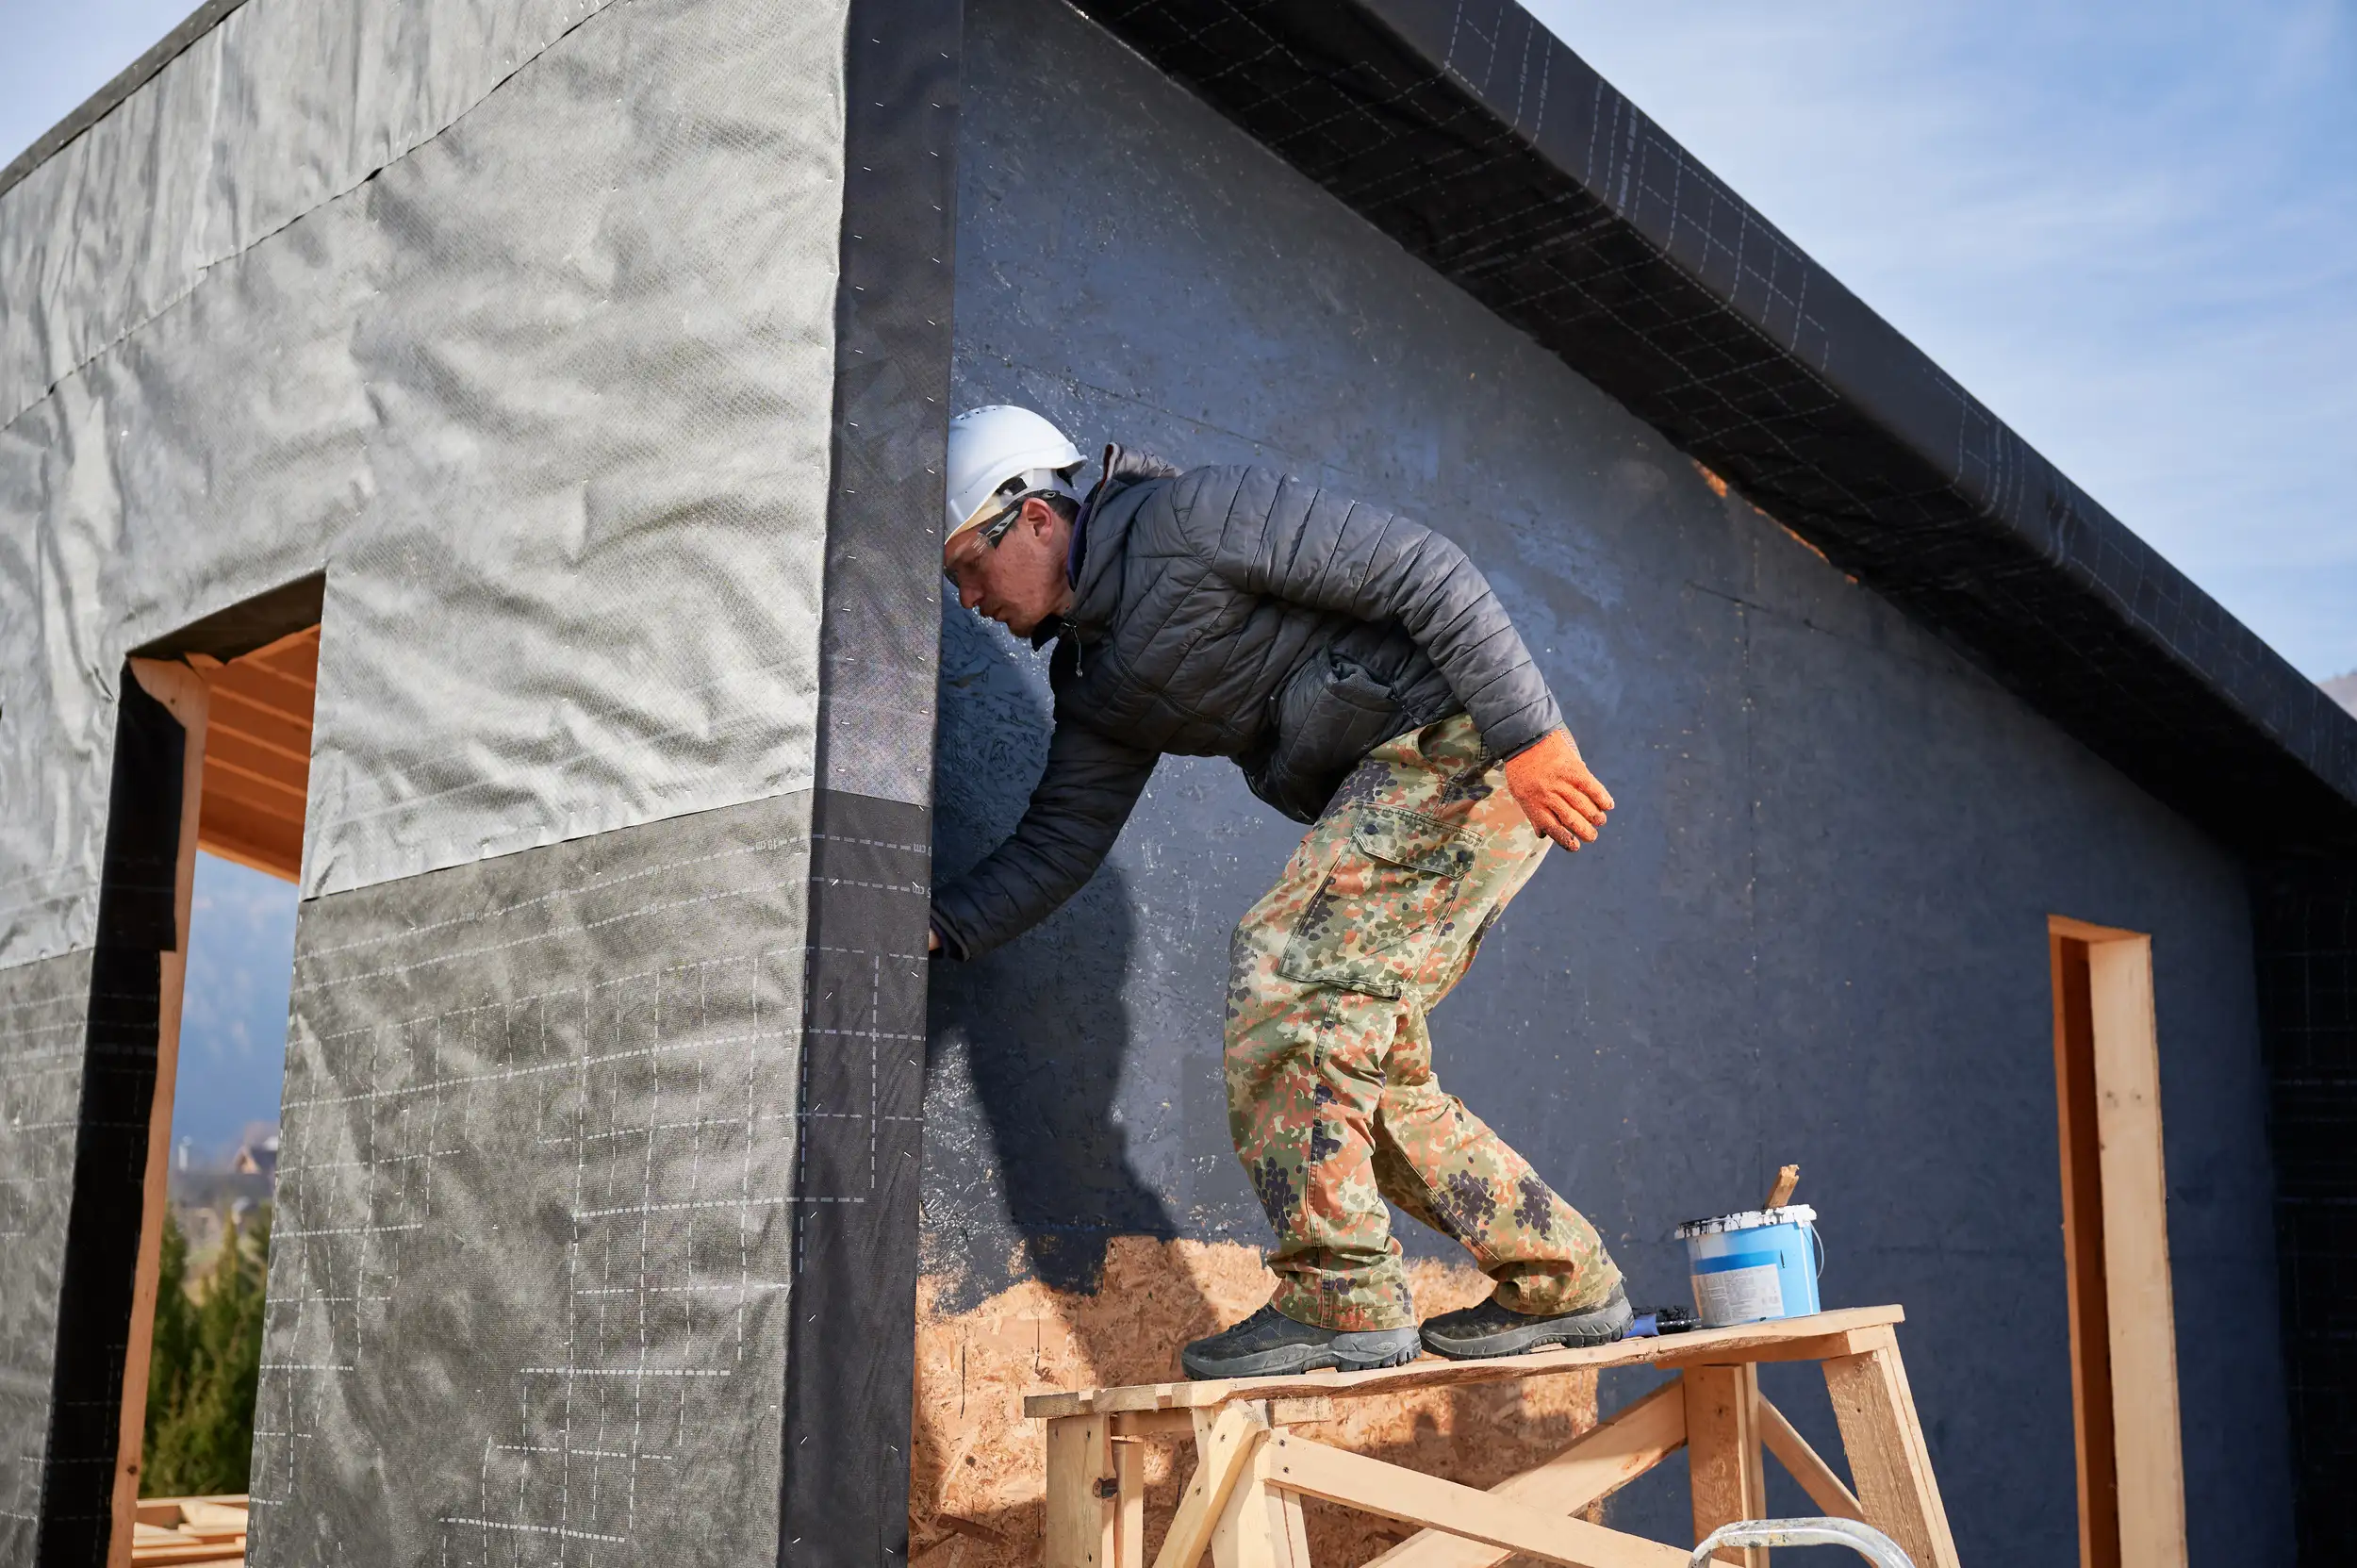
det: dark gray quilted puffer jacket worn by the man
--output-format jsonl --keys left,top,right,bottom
{"left": 933, "top": 453, "right": 1563, "bottom": 957}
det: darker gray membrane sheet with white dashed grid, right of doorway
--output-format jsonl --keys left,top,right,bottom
{"left": 253, "top": 795, "right": 811, "bottom": 1565}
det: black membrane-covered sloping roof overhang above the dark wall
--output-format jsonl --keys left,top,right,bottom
{"left": 0, "top": 0, "right": 2357, "bottom": 853}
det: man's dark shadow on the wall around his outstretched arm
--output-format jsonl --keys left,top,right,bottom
{"left": 927, "top": 599, "right": 1210, "bottom": 1311}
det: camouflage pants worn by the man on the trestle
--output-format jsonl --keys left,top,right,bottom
{"left": 1226, "top": 717, "right": 1620, "bottom": 1329}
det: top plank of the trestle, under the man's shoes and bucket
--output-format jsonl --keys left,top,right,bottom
{"left": 1023, "top": 1306, "right": 1907, "bottom": 1419}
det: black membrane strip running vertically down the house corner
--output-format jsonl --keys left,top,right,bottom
{"left": 778, "top": 0, "right": 960, "bottom": 1563}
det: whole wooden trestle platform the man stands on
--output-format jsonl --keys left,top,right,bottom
{"left": 1023, "top": 1306, "right": 1956, "bottom": 1568}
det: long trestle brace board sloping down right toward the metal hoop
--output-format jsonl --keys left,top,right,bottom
{"left": 1268, "top": 1431, "right": 1688, "bottom": 1568}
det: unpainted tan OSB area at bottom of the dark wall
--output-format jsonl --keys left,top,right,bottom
{"left": 910, "top": 1235, "right": 1596, "bottom": 1568}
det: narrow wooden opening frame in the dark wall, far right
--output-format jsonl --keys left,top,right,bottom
{"left": 2046, "top": 915, "right": 2185, "bottom": 1568}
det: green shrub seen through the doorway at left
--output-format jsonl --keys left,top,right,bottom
{"left": 140, "top": 1205, "right": 272, "bottom": 1497}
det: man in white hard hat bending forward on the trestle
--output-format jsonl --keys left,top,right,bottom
{"left": 931, "top": 408, "right": 1629, "bottom": 1377}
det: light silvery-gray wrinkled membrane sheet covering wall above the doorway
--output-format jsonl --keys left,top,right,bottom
{"left": 0, "top": 0, "right": 844, "bottom": 965}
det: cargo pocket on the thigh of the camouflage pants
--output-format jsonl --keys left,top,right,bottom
{"left": 1277, "top": 806, "right": 1480, "bottom": 998}
